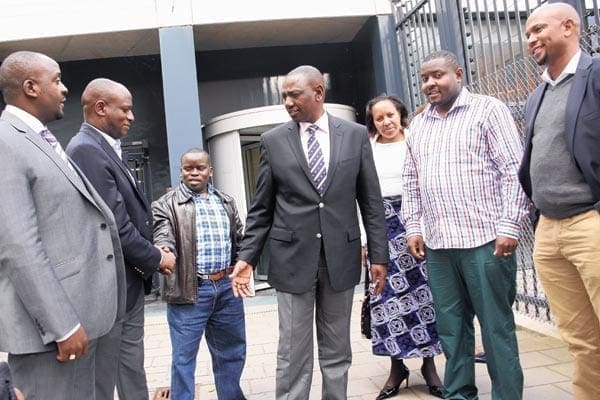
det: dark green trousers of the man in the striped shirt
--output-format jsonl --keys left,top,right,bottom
{"left": 427, "top": 242, "right": 523, "bottom": 400}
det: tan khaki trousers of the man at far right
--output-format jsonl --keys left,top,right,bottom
{"left": 533, "top": 210, "right": 600, "bottom": 400}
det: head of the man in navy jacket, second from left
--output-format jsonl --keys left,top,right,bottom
{"left": 81, "top": 78, "right": 134, "bottom": 139}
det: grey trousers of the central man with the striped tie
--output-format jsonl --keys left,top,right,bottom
{"left": 275, "top": 261, "right": 354, "bottom": 400}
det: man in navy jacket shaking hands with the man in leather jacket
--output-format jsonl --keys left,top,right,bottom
{"left": 67, "top": 78, "right": 175, "bottom": 400}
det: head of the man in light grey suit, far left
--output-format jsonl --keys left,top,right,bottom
{"left": 0, "top": 51, "right": 68, "bottom": 124}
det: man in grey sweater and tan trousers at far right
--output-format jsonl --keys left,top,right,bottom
{"left": 519, "top": 3, "right": 600, "bottom": 400}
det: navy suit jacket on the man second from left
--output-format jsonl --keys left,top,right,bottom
{"left": 66, "top": 123, "right": 160, "bottom": 309}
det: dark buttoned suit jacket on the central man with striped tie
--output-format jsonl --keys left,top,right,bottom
{"left": 238, "top": 115, "right": 388, "bottom": 293}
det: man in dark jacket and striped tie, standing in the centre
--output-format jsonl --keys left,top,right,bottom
{"left": 231, "top": 66, "right": 388, "bottom": 399}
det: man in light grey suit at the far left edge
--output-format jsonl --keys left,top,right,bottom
{"left": 0, "top": 51, "right": 125, "bottom": 400}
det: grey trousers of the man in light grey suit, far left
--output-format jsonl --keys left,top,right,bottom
{"left": 8, "top": 340, "right": 97, "bottom": 400}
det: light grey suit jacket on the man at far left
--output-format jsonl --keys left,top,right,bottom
{"left": 0, "top": 112, "right": 125, "bottom": 354}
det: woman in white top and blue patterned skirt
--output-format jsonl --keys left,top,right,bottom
{"left": 366, "top": 96, "right": 444, "bottom": 400}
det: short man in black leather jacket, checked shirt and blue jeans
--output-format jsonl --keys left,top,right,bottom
{"left": 152, "top": 148, "right": 246, "bottom": 400}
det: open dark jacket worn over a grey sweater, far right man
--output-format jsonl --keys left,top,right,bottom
{"left": 519, "top": 53, "right": 600, "bottom": 216}
